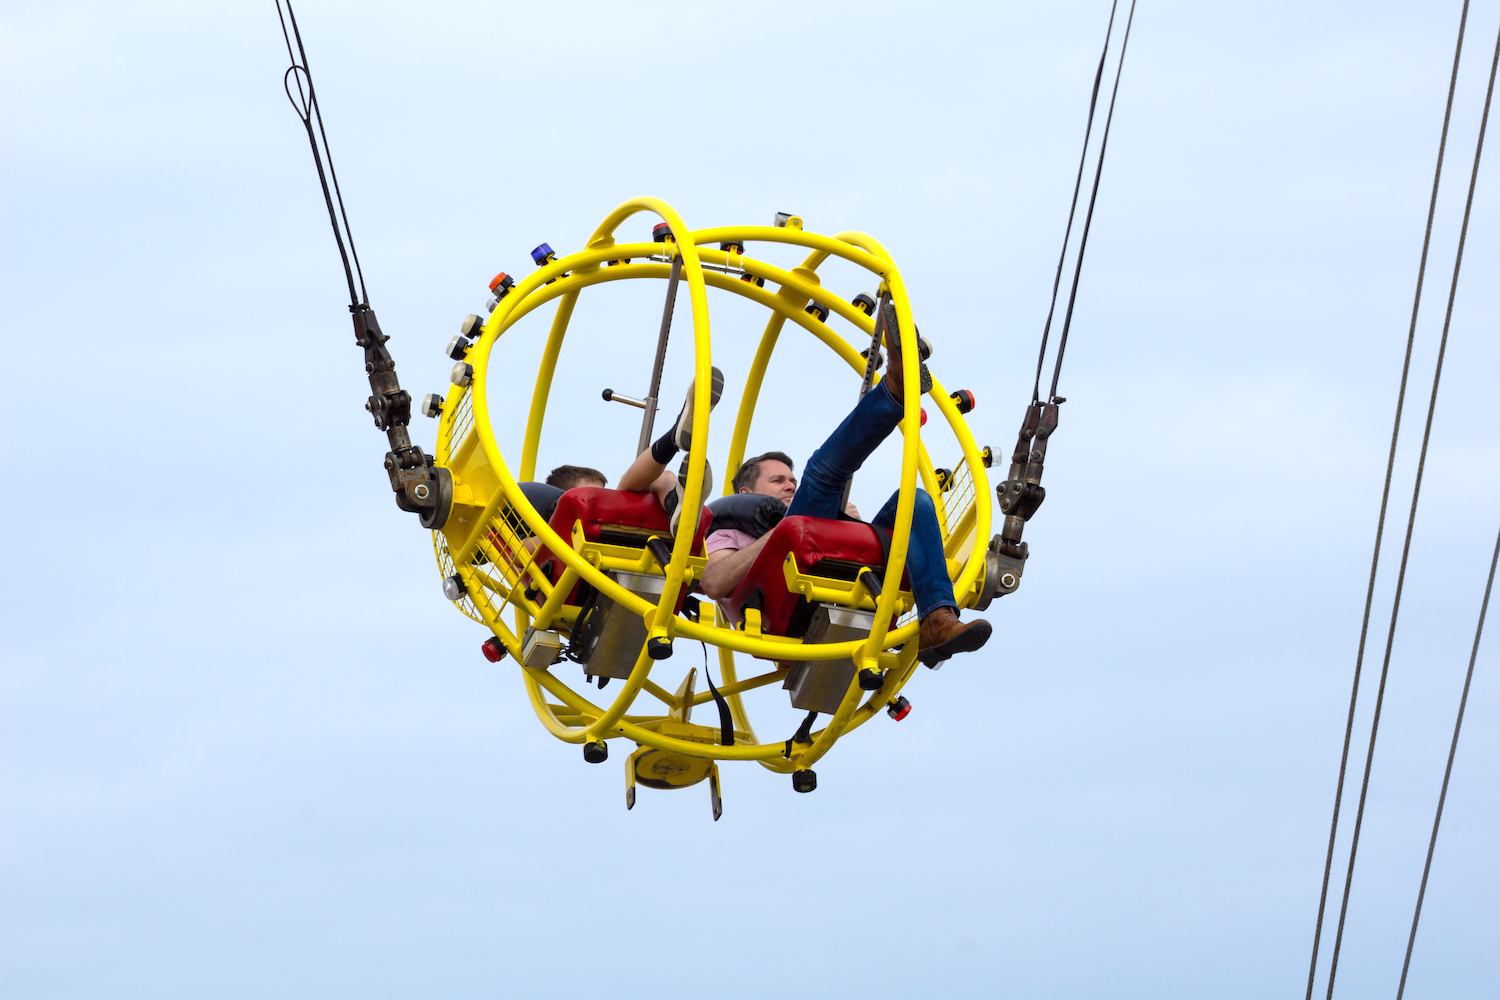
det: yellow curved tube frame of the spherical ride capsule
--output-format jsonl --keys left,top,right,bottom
{"left": 437, "top": 198, "right": 990, "bottom": 772}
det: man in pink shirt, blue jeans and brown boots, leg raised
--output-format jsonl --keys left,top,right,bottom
{"left": 701, "top": 306, "right": 990, "bottom": 667}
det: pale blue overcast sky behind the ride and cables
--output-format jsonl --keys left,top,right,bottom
{"left": 0, "top": 0, "right": 1500, "bottom": 1000}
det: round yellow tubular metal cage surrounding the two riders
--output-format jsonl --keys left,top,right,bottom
{"left": 456, "top": 198, "right": 990, "bottom": 771}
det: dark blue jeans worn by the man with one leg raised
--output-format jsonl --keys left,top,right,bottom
{"left": 786, "top": 382, "right": 959, "bottom": 618}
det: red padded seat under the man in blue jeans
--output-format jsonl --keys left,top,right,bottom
{"left": 725, "top": 516, "right": 911, "bottom": 639}
